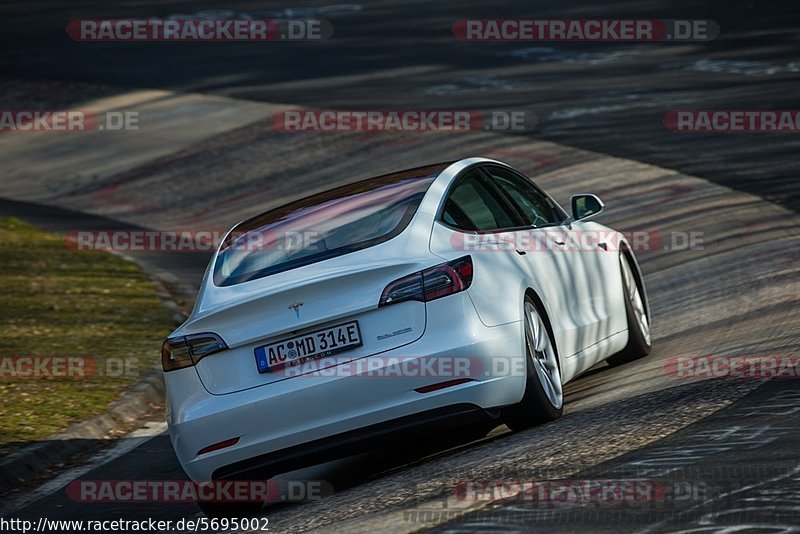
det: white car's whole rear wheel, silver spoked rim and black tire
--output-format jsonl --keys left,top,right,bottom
{"left": 505, "top": 296, "right": 564, "bottom": 432}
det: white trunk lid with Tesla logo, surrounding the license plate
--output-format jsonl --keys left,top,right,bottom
{"left": 185, "top": 249, "right": 436, "bottom": 395}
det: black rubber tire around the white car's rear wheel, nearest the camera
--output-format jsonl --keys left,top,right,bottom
{"left": 504, "top": 295, "right": 564, "bottom": 432}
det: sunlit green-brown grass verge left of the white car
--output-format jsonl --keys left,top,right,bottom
{"left": 0, "top": 218, "right": 174, "bottom": 454}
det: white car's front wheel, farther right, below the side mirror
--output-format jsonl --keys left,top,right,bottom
{"left": 607, "top": 254, "right": 651, "bottom": 365}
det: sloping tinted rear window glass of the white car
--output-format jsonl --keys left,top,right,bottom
{"left": 214, "top": 163, "right": 449, "bottom": 286}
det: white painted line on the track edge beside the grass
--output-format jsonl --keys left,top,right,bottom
{"left": 0, "top": 422, "right": 167, "bottom": 516}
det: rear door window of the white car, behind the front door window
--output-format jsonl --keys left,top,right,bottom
{"left": 442, "top": 170, "right": 516, "bottom": 231}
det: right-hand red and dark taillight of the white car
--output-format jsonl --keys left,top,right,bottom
{"left": 378, "top": 256, "right": 472, "bottom": 306}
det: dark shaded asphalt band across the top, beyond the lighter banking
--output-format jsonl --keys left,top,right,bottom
{"left": 0, "top": 0, "right": 800, "bottom": 210}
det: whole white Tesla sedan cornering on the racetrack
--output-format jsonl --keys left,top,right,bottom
{"left": 162, "top": 158, "right": 650, "bottom": 516}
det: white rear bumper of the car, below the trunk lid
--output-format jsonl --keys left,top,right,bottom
{"left": 165, "top": 294, "right": 525, "bottom": 480}
